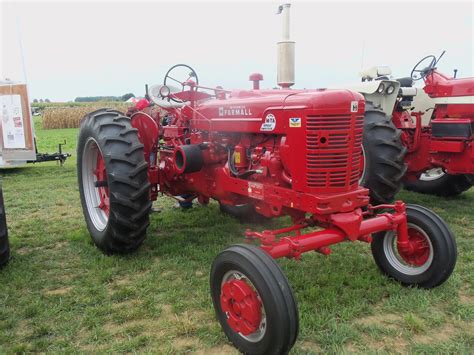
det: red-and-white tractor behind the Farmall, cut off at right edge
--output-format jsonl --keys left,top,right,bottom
{"left": 353, "top": 52, "right": 474, "bottom": 201}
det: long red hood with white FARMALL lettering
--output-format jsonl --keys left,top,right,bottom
{"left": 192, "top": 89, "right": 364, "bottom": 134}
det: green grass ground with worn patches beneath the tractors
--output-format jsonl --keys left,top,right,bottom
{"left": 0, "top": 120, "right": 474, "bottom": 353}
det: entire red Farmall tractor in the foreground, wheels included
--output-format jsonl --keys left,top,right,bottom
{"left": 77, "top": 65, "right": 456, "bottom": 354}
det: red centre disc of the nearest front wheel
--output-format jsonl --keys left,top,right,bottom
{"left": 221, "top": 279, "right": 262, "bottom": 336}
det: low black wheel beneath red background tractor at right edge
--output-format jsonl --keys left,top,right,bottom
{"left": 404, "top": 168, "right": 474, "bottom": 197}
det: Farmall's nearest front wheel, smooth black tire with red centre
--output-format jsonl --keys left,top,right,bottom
{"left": 210, "top": 244, "right": 298, "bottom": 354}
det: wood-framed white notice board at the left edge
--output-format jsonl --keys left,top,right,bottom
{"left": 0, "top": 82, "right": 36, "bottom": 167}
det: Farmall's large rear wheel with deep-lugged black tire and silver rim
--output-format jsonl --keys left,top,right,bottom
{"left": 77, "top": 109, "right": 152, "bottom": 254}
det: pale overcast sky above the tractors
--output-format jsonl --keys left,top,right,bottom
{"left": 0, "top": 0, "right": 474, "bottom": 101}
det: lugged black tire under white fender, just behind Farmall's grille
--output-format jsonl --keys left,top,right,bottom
{"left": 360, "top": 103, "right": 407, "bottom": 205}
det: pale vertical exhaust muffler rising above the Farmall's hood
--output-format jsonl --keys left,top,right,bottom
{"left": 277, "top": 4, "right": 295, "bottom": 89}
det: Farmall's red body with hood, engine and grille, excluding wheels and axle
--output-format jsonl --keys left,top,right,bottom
{"left": 130, "top": 90, "right": 367, "bottom": 217}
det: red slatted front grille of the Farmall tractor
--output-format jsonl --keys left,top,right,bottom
{"left": 306, "top": 115, "right": 364, "bottom": 192}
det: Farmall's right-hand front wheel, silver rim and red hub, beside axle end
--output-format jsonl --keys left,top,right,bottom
{"left": 372, "top": 205, "right": 457, "bottom": 288}
